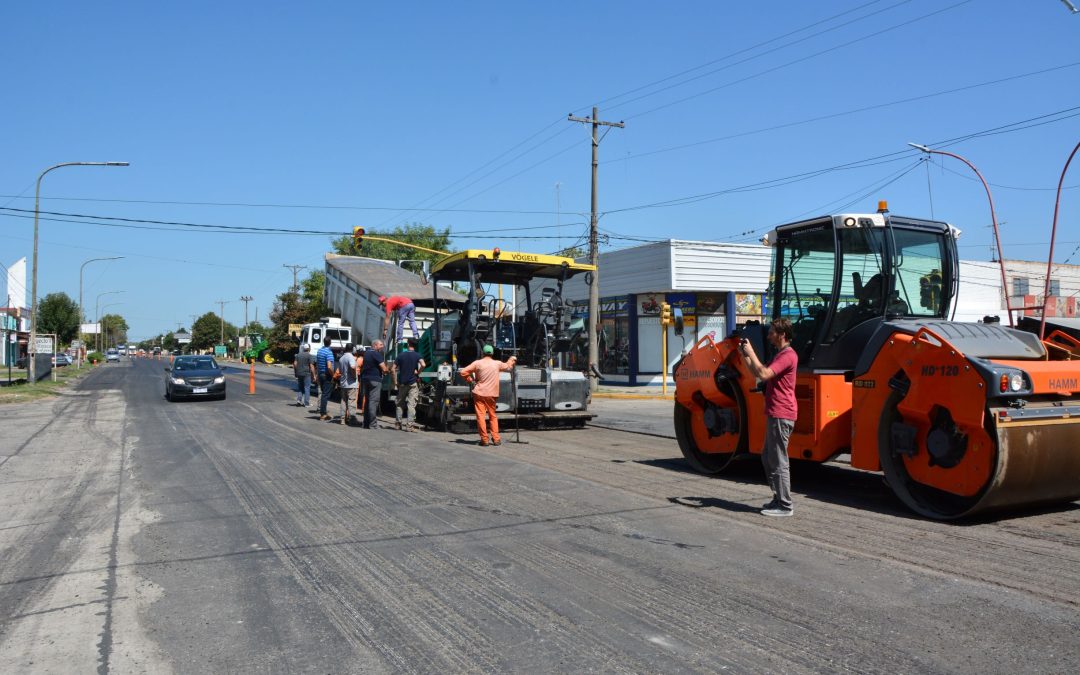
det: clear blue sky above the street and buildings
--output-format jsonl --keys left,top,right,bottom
{"left": 0, "top": 0, "right": 1080, "bottom": 338}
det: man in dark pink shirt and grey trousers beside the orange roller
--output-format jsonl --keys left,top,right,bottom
{"left": 739, "top": 319, "right": 799, "bottom": 516}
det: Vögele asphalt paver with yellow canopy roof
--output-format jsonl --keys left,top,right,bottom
{"left": 406, "top": 248, "right": 595, "bottom": 432}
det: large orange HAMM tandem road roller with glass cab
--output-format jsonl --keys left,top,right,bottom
{"left": 674, "top": 212, "right": 1080, "bottom": 519}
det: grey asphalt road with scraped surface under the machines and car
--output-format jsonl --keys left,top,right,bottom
{"left": 0, "top": 360, "right": 1080, "bottom": 673}
